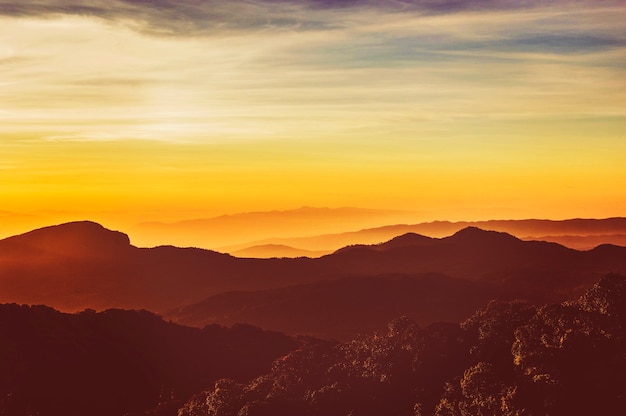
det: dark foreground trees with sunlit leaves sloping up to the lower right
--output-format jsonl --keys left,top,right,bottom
{"left": 179, "top": 275, "right": 626, "bottom": 416}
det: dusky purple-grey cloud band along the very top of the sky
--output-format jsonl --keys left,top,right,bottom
{"left": 0, "top": 0, "right": 620, "bottom": 36}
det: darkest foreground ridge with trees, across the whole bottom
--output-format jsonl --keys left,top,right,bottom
{"left": 0, "top": 274, "right": 626, "bottom": 416}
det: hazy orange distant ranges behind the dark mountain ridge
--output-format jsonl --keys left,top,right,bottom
{"left": 129, "top": 207, "right": 626, "bottom": 257}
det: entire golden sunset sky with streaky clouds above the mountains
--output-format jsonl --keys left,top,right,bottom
{"left": 0, "top": 0, "right": 626, "bottom": 239}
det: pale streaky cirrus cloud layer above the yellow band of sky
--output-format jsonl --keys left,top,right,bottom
{"left": 0, "top": 0, "right": 626, "bottom": 140}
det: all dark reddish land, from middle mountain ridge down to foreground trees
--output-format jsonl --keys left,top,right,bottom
{"left": 0, "top": 221, "right": 626, "bottom": 416}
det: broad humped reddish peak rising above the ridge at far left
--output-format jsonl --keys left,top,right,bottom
{"left": 0, "top": 221, "right": 130, "bottom": 255}
